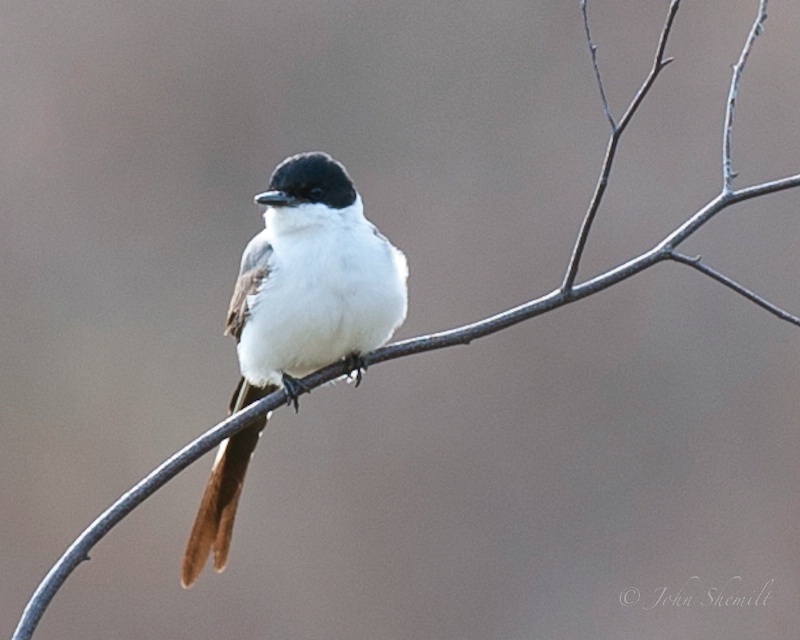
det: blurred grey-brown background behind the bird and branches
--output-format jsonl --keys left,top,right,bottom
{"left": 0, "top": 0, "right": 800, "bottom": 640}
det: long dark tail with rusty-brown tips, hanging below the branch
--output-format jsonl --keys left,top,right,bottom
{"left": 181, "top": 378, "right": 276, "bottom": 589}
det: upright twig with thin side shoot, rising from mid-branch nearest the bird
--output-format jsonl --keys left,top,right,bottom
{"left": 561, "top": 0, "right": 681, "bottom": 294}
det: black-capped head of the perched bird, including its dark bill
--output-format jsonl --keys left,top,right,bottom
{"left": 255, "top": 151, "right": 356, "bottom": 209}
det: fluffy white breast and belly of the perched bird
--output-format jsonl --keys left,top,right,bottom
{"left": 231, "top": 225, "right": 406, "bottom": 386}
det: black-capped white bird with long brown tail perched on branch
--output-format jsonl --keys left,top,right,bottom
{"left": 181, "top": 151, "right": 408, "bottom": 588}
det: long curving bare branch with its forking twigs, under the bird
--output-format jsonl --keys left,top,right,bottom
{"left": 12, "top": 0, "right": 800, "bottom": 640}
